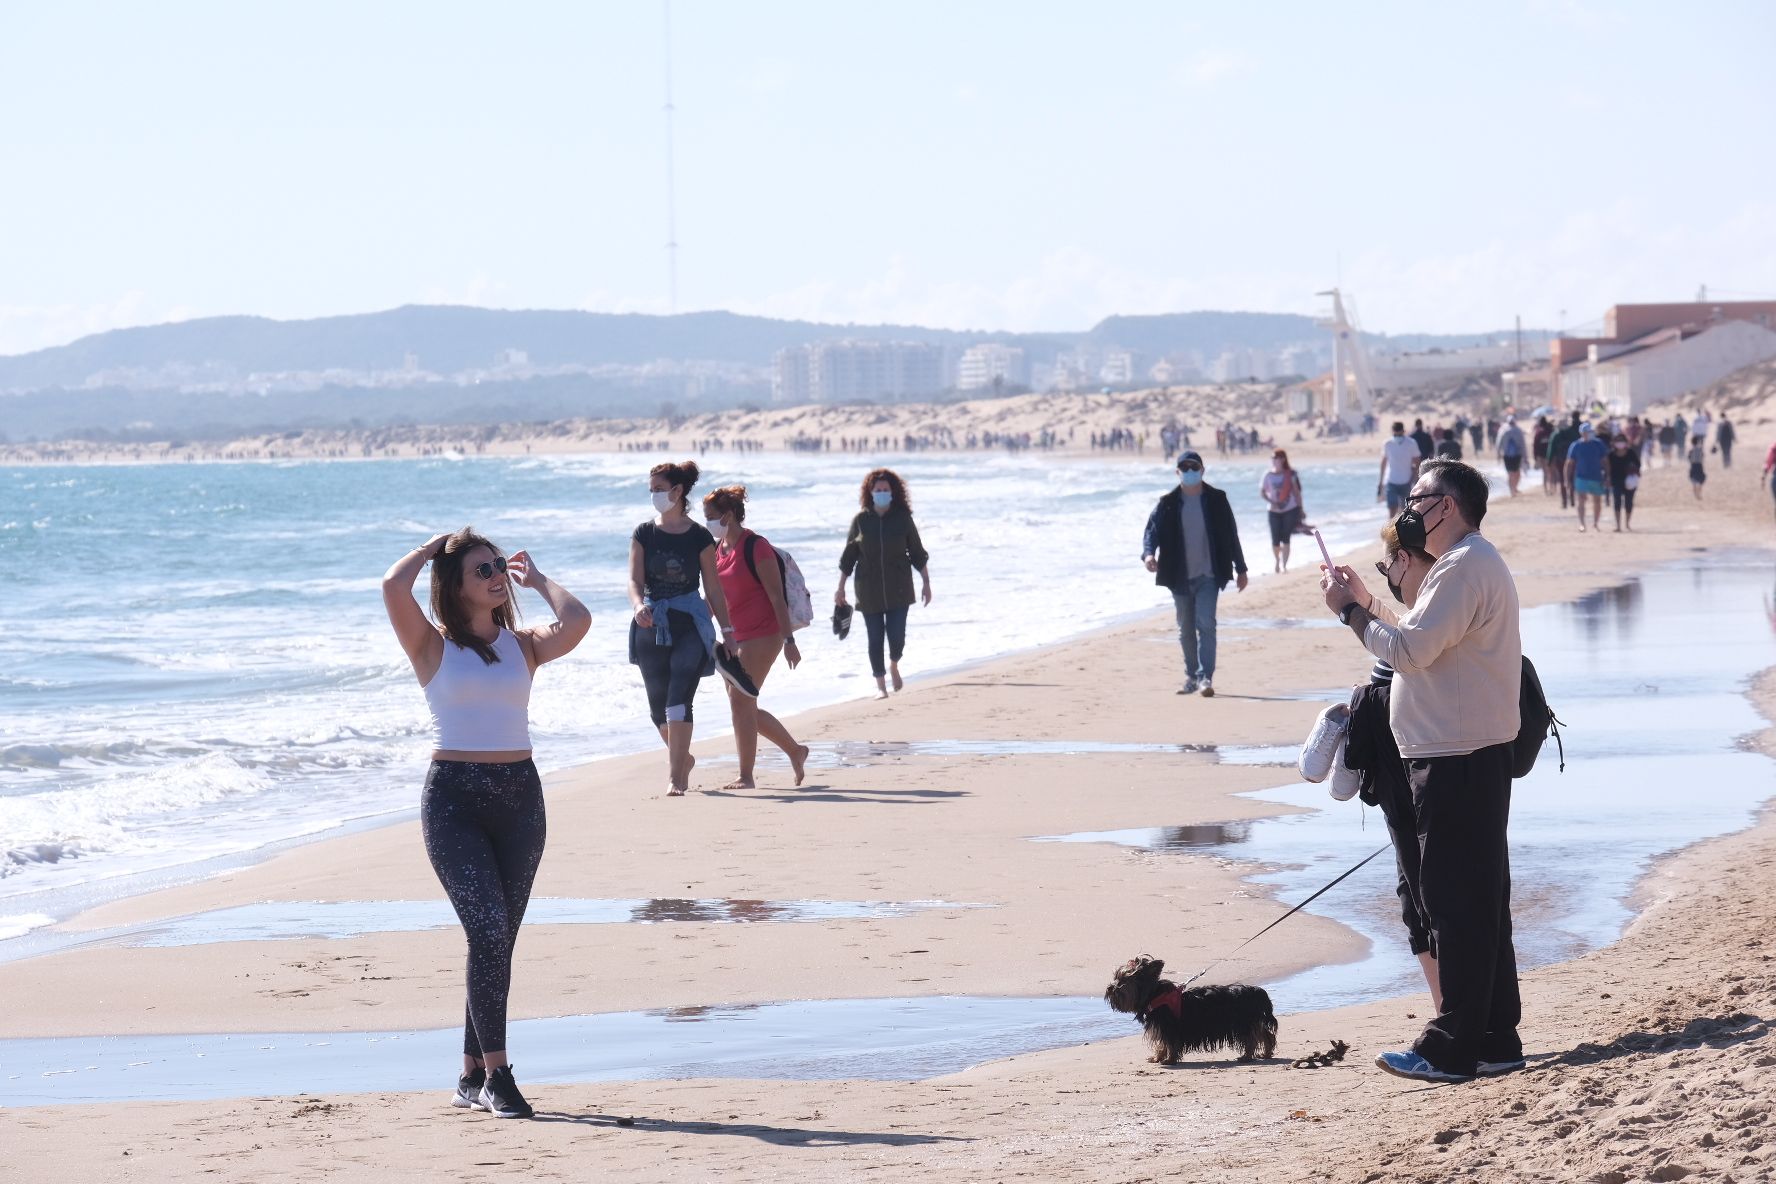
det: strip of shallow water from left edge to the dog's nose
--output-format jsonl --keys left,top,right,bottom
{"left": 0, "top": 996, "right": 1130, "bottom": 1108}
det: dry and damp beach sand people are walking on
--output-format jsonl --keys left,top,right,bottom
{"left": 0, "top": 438, "right": 1776, "bottom": 1182}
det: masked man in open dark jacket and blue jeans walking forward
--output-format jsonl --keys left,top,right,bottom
{"left": 1140, "top": 451, "right": 1247, "bottom": 698}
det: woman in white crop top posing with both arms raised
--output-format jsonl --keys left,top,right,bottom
{"left": 382, "top": 527, "right": 591, "bottom": 1118}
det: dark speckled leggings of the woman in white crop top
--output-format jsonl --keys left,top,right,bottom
{"left": 419, "top": 760, "right": 547, "bottom": 1058}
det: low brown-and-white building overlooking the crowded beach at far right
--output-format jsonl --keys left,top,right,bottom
{"left": 1549, "top": 300, "right": 1776, "bottom": 415}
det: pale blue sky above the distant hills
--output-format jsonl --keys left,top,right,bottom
{"left": 0, "top": 0, "right": 1776, "bottom": 353}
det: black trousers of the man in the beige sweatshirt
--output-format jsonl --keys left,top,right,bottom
{"left": 1407, "top": 744, "right": 1524, "bottom": 1074}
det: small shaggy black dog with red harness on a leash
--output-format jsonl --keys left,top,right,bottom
{"left": 1105, "top": 955, "right": 1277, "bottom": 1065}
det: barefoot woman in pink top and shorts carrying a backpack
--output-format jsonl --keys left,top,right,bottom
{"left": 703, "top": 485, "right": 808, "bottom": 790}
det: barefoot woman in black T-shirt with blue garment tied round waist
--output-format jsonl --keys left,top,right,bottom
{"left": 629, "top": 460, "right": 738, "bottom": 797}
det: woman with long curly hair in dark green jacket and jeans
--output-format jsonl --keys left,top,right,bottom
{"left": 833, "top": 469, "right": 931, "bottom": 699}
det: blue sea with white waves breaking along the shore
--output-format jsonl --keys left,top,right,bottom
{"left": 0, "top": 451, "right": 1382, "bottom": 939}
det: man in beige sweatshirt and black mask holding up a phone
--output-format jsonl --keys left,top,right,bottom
{"left": 1320, "top": 460, "right": 1524, "bottom": 1081}
